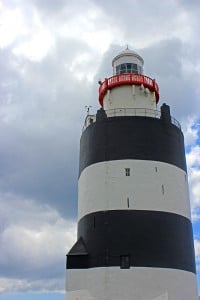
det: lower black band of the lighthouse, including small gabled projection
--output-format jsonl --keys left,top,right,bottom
{"left": 67, "top": 210, "right": 196, "bottom": 273}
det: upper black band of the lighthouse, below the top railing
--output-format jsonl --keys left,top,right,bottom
{"left": 79, "top": 117, "right": 186, "bottom": 174}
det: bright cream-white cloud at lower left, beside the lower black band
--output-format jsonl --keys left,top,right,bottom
{"left": 0, "top": 220, "right": 76, "bottom": 272}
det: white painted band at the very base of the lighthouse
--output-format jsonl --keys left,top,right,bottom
{"left": 66, "top": 267, "right": 198, "bottom": 300}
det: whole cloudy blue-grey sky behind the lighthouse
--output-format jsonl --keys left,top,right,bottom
{"left": 0, "top": 0, "right": 200, "bottom": 300}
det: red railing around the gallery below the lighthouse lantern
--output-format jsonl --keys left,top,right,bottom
{"left": 99, "top": 73, "right": 159, "bottom": 106}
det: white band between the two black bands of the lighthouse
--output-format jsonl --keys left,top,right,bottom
{"left": 78, "top": 159, "right": 190, "bottom": 220}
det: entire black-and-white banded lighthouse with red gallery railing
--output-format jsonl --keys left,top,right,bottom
{"left": 66, "top": 48, "right": 198, "bottom": 300}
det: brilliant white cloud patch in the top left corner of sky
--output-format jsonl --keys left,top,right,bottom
{"left": 0, "top": 4, "right": 54, "bottom": 61}
